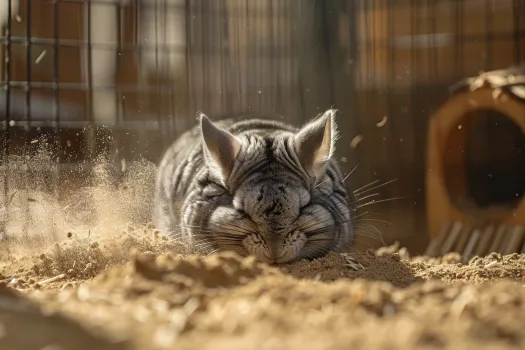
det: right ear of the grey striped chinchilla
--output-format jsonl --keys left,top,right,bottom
{"left": 294, "top": 109, "right": 338, "bottom": 179}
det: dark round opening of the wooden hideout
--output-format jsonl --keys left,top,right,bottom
{"left": 444, "top": 109, "right": 525, "bottom": 213}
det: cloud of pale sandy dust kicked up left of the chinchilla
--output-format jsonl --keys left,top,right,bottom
{"left": 0, "top": 147, "right": 184, "bottom": 277}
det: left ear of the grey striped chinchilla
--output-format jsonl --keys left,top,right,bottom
{"left": 200, "top": 114, "right": 241, "bottom": 179}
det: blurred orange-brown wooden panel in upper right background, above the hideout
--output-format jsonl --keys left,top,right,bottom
{"left": 348, "top": 0, "right": 525, "bottom": 88}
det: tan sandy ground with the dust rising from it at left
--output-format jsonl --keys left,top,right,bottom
{"left": 0, "top": 157, "right": 525, "bottom": 350}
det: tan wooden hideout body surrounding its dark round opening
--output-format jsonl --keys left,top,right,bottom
{"left": 426, "top": 66, "right": 525, "bottom": 256}
